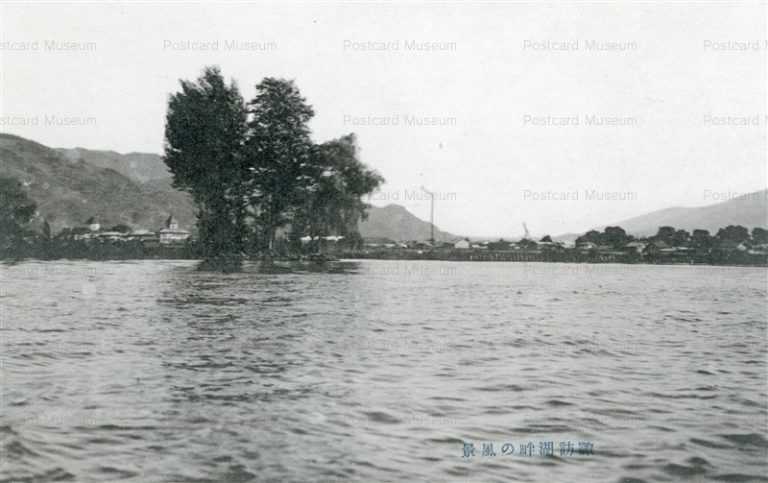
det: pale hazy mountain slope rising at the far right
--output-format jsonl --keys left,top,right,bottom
{"left": 554, "top": 190, "right": 768, "bottom": 241}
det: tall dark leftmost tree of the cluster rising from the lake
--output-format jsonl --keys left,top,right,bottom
{"left": 165, "top": 67, "right": 247, "bottom": 259}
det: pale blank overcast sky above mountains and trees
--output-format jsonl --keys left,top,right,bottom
{"left": 0, "top": 2, "right": 768, "bottom": 236}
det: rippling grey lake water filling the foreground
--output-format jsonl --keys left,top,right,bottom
{"left": 0, "top": 261, "right": 768, "bottom": 483}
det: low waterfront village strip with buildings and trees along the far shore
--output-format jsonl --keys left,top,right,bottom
{"left": 48, "top": 215, "right": 768, "bottom": 266}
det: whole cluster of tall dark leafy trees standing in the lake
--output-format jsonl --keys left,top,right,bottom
{"left": 165, "top": 67, "right": 383, "bottom": 259}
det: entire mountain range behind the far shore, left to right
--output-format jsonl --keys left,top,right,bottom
{"left": 0, "top": 133, "right": 768, "bottom": 241}
